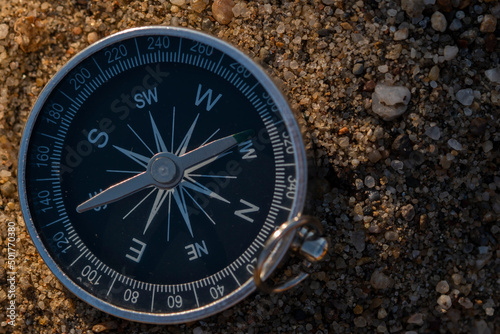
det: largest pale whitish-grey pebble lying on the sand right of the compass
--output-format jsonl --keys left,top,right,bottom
{"left": 372, "top": 84, "right": 411, "bottom": 121}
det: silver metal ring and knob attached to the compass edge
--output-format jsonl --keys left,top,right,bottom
{"left": 254, "top": 216, "right": 328, "bottom": 293}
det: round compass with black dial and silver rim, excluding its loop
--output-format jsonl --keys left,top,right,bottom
{"left": 19, "top": 27, "right": 306, "bottom": 323}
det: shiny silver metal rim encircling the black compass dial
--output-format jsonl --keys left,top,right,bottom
{"left": 18, "top": 26, "right": 307, "bottom": 324}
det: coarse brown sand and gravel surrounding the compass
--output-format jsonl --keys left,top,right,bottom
{"left": 0, "top": 0, "right": 500, "bottom": 334}
